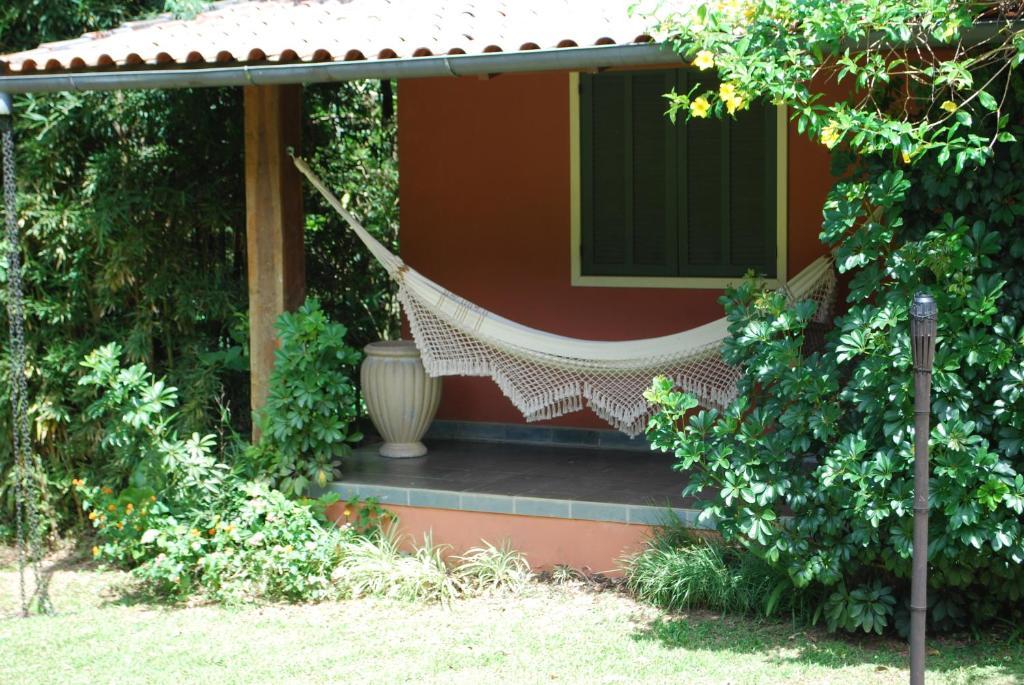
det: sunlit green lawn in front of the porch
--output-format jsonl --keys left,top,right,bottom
{"left": 0, "top": 548, "right": 1024, "bottom": 685}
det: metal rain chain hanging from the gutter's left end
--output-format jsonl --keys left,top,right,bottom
{"left": 0, "top": 117, "right": 50, "bottom": 615}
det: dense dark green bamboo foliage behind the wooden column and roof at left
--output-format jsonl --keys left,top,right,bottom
{"left": 0, "top": 0, "right": 398, "bottom": 529}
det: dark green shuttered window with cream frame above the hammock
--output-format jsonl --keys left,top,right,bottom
{"left": 572, "top": 69, "right": 785, "bottom": 288}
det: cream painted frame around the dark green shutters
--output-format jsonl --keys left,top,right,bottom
{"left": 569, "top": 72, "right": 790, "bottom": 290}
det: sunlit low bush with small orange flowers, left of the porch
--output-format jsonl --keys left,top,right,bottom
{"left": 72, "top": 344, "right": 360, "bottom": 601}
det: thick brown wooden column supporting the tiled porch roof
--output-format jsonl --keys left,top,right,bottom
{"left": 245, "top": 86, "right": 306, "bottom": 427}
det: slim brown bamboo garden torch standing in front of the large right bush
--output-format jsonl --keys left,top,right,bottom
{"left": 910, "top": 293, "right": 938, "bottom": 685}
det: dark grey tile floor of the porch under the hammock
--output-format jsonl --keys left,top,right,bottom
{"left": 342, "top": 439, "right": 693, "bottom": 508}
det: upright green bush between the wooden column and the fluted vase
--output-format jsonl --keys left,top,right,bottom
{"left": 247, "top": 298, "right": 362, "bottom": 496}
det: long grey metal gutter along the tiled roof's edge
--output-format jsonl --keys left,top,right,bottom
{"left": 0, "top": 43, "right": 681, "bottom": 93}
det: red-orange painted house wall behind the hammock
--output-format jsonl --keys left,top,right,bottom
{"left": 398, "top": 68, "right": 830, "bottom": 427}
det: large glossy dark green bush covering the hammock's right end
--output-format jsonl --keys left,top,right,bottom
{"left": 647, "top": 140, "right": 1024, "bottom": 632}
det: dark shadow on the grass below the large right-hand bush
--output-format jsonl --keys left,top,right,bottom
{"left": 633, "top": 612, "right": 1024, "bottom": 682}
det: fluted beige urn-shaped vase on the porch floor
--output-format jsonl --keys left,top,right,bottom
{"left": 359, "top": 340, "right": 441, "bottom": 458}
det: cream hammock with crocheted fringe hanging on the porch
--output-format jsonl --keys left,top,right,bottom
{"left": 294, "top": 158, "right": 836, "bottom": 435}
